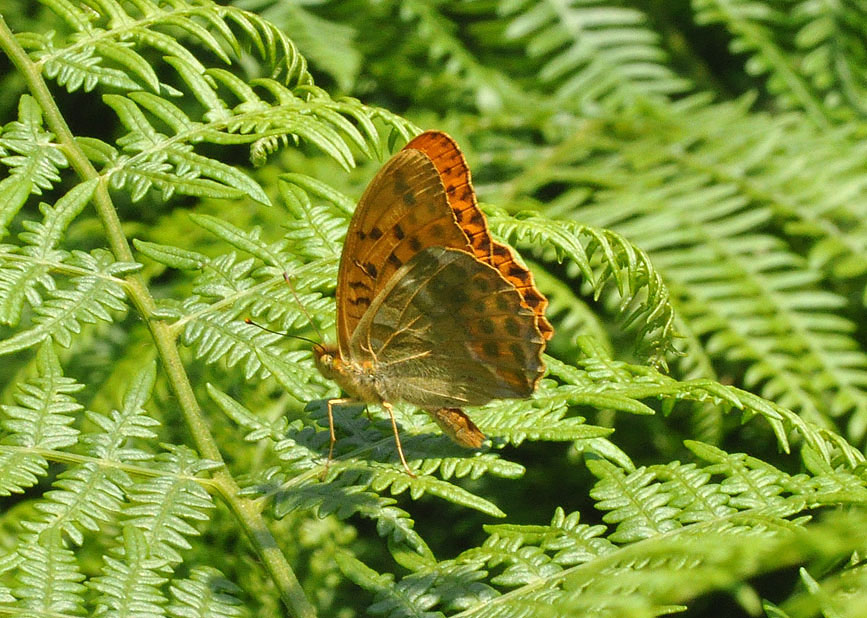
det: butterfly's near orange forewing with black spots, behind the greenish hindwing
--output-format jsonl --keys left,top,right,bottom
{"left": 337, "top": 149, "right": 469, "bottom": 356}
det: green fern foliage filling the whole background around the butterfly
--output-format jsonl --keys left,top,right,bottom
{"left": 0, "top": 0, "right": 867, "bottom": 618}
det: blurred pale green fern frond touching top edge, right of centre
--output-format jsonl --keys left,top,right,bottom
{"left": 498, "top": 0, "right": 689, "bottom": 110}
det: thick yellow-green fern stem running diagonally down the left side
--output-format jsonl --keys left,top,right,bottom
{"left": 0, "top": 15, "right": 316, "bottom": 618}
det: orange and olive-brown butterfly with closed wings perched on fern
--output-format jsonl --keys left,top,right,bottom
{"left": 313, "top": 131, "right": 554, "bottom": 476}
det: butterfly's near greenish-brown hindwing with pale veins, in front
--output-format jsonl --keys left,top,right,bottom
{"left": 349, "top": 247, "right": 545, "bottom": 408}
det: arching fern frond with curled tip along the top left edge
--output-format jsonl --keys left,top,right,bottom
{"left": 19, "top": 0, "right": 312, "bottom": 92}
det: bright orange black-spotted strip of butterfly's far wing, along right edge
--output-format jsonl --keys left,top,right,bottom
{"left": 404, "top": 131, "right": 554, "bottom": 340}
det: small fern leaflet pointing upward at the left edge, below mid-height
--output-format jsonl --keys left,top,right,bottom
{"left": 0, "top": 343, "right": 84, "bottom": 496}
